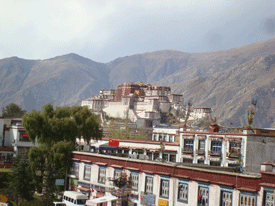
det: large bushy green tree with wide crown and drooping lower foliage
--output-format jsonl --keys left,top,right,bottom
{"left": 23, "top": 104, "right": 102, "bottom": 205}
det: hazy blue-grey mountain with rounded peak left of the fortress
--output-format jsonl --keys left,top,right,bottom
{"left": 0, "top": 54, "right": 110, "bottom": 111}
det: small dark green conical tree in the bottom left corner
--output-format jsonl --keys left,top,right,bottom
{"left": 9, "top": 155, "right": 34, "bottom": 204}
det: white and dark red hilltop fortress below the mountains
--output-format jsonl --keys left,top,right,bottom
{"left": 81, "top": 82, "right": 184, "bottom": 125}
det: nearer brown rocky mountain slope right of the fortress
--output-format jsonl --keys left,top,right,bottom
{"left": 172, "top": 55, "right": 275, "bottom": 127}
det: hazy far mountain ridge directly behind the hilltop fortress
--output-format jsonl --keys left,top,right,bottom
{"left": 107, "top": 39, "right": 275, "bottom": 87}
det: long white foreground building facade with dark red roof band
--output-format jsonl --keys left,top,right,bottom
{"left": 68, "top": 152, "right": 275, "bottom": 206}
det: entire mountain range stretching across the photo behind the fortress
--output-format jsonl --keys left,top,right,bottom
{"left": 0, "top": 39, "right": 275, "bottom": 127}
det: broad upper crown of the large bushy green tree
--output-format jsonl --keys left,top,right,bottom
{"left": 23, "top": 104, "right": 102, "bottom": 146}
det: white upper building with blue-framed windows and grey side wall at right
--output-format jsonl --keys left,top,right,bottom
{"left": 179, "top": 125, "right": 275, "bottom": 172}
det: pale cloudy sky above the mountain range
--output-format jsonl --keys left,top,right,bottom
{"left": 0, "top": 0, "right": 275, "bottom": 63}
